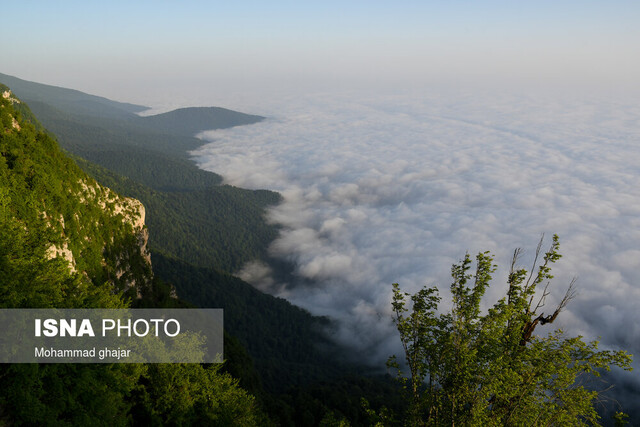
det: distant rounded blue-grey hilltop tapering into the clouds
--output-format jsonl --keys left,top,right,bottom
{"left": 139, "top": 107, "right": 265, "bottom": 136}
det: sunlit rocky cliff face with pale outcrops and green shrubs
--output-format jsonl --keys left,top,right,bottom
{"left": 0, "top": 85, "right": 153, "bottom": 304}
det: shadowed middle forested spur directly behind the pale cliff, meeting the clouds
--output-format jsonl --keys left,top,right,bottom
{"left": 78, "top": 155, "right": 279, "bottom": 272}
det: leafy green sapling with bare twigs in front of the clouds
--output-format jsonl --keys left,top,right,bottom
{"left": 387, "top": 235, "right": 632, "bottom": 425}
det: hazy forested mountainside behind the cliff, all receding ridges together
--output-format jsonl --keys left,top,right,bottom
{"left": 0, "top": 75, "right": 280, "bottom": 272}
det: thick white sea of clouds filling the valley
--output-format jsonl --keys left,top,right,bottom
{"left": 192, "top": 87, "right": 640, "bottom": 372}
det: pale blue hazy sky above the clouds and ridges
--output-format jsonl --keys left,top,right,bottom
{"left": 0, "top": 0, "right": 640, "bottom": 102}
